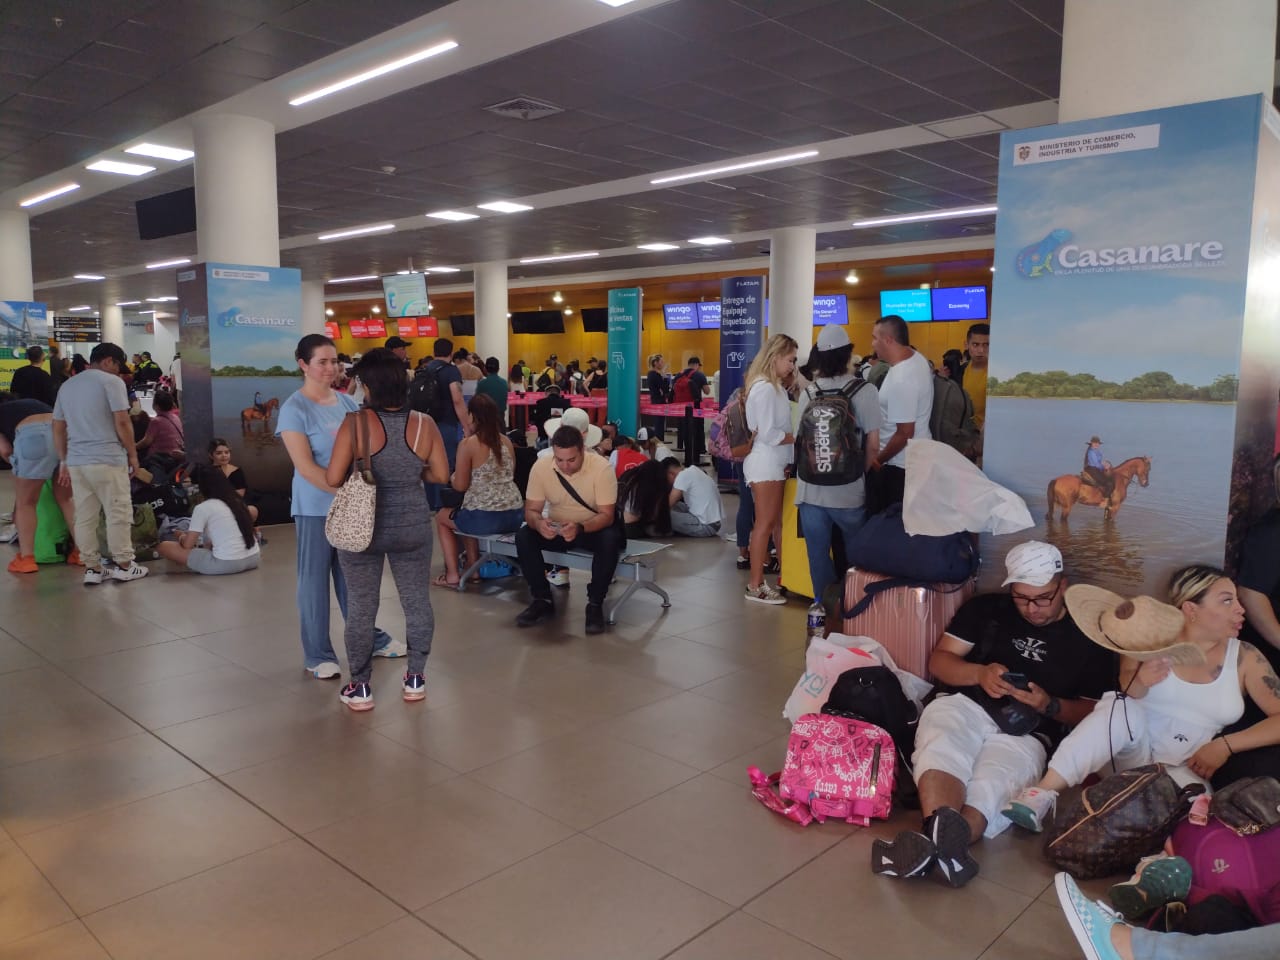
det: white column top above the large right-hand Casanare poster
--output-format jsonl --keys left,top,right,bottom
{"left": 1057, "top": 0, "right": 1276, "bottom": 123}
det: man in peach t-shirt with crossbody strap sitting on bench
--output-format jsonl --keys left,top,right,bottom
{"left": 516, "top": 426, "right": 625, "bottom": 634}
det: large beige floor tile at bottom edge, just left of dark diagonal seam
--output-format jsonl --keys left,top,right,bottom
{"left": 83, "top": 840, "right": 403, "bottom": 960}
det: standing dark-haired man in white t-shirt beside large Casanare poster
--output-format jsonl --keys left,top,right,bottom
{"left": 867, "top": 314, "right": 933, "bottom": 515}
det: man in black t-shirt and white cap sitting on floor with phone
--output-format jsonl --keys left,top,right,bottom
{"left": 872, "top": 540, "right": 1115, "bottom": 887}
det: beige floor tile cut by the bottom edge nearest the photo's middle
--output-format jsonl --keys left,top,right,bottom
{"left": 420, "top": 836, "right": 730, "bottom": 960}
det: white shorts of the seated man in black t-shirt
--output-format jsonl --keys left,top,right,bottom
{"left": 911, "top": 694, "right": 1044, "bottom": 838}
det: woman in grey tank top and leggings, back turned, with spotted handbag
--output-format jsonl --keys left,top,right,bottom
{"left": 325, "top": 347, "right": 449, "bottom": 710}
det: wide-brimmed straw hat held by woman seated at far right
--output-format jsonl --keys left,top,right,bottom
{"left": 1066, "top": 584, "right": 1204, "bottom": 664}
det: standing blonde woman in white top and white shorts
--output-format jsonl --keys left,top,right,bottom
{"left": 742, "top": 334, "right": 799, "bottom": 604}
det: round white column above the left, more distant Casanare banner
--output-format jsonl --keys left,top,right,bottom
{"left": 192, "top": 114, "right": 280, "bottom": 266}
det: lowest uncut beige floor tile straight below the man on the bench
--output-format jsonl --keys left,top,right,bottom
{"left": 471, "top": 732, "right": 698, "bottom": 829}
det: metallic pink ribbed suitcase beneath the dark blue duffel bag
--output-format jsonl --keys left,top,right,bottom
{"left": 841, "top": 567, "right": 978, "bottom": 681}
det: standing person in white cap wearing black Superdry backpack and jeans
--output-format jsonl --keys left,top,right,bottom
{"left": 796, "top": 326, "right": 881, "bottom": 600}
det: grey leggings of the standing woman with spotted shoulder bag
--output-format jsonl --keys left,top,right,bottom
{"left": 338, "top": 524, "right": 435, "bottom": 684}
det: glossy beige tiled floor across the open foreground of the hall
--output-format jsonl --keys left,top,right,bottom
{"left": 0, "top": 474, "right": 1076, "bottom": 960}
